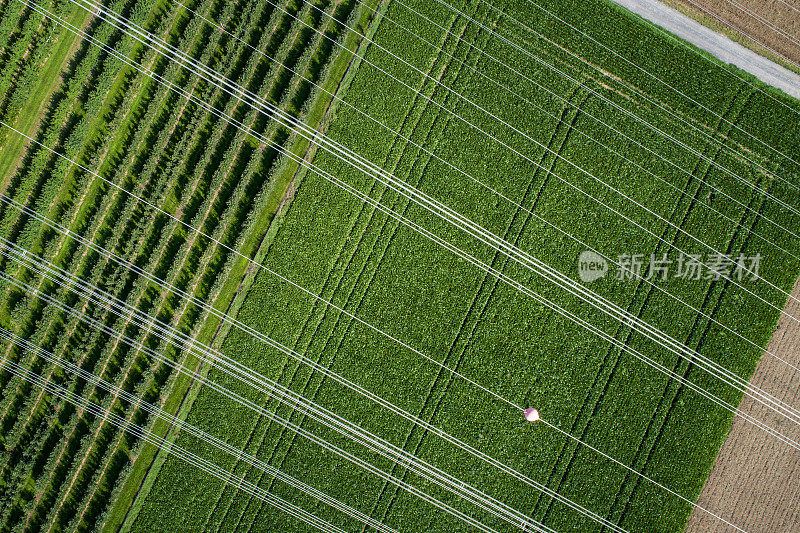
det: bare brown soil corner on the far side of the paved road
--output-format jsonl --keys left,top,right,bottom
{"left": 662, "top": 0, "right": 800, "bottom": 71}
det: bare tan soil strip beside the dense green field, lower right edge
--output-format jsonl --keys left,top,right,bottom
{"left": 686, "top": 280, "right": 800, "bottom": 533}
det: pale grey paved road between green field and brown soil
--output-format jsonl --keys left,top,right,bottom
{"left": 612, "top": 0, "right": 800, "bottom": 99}
